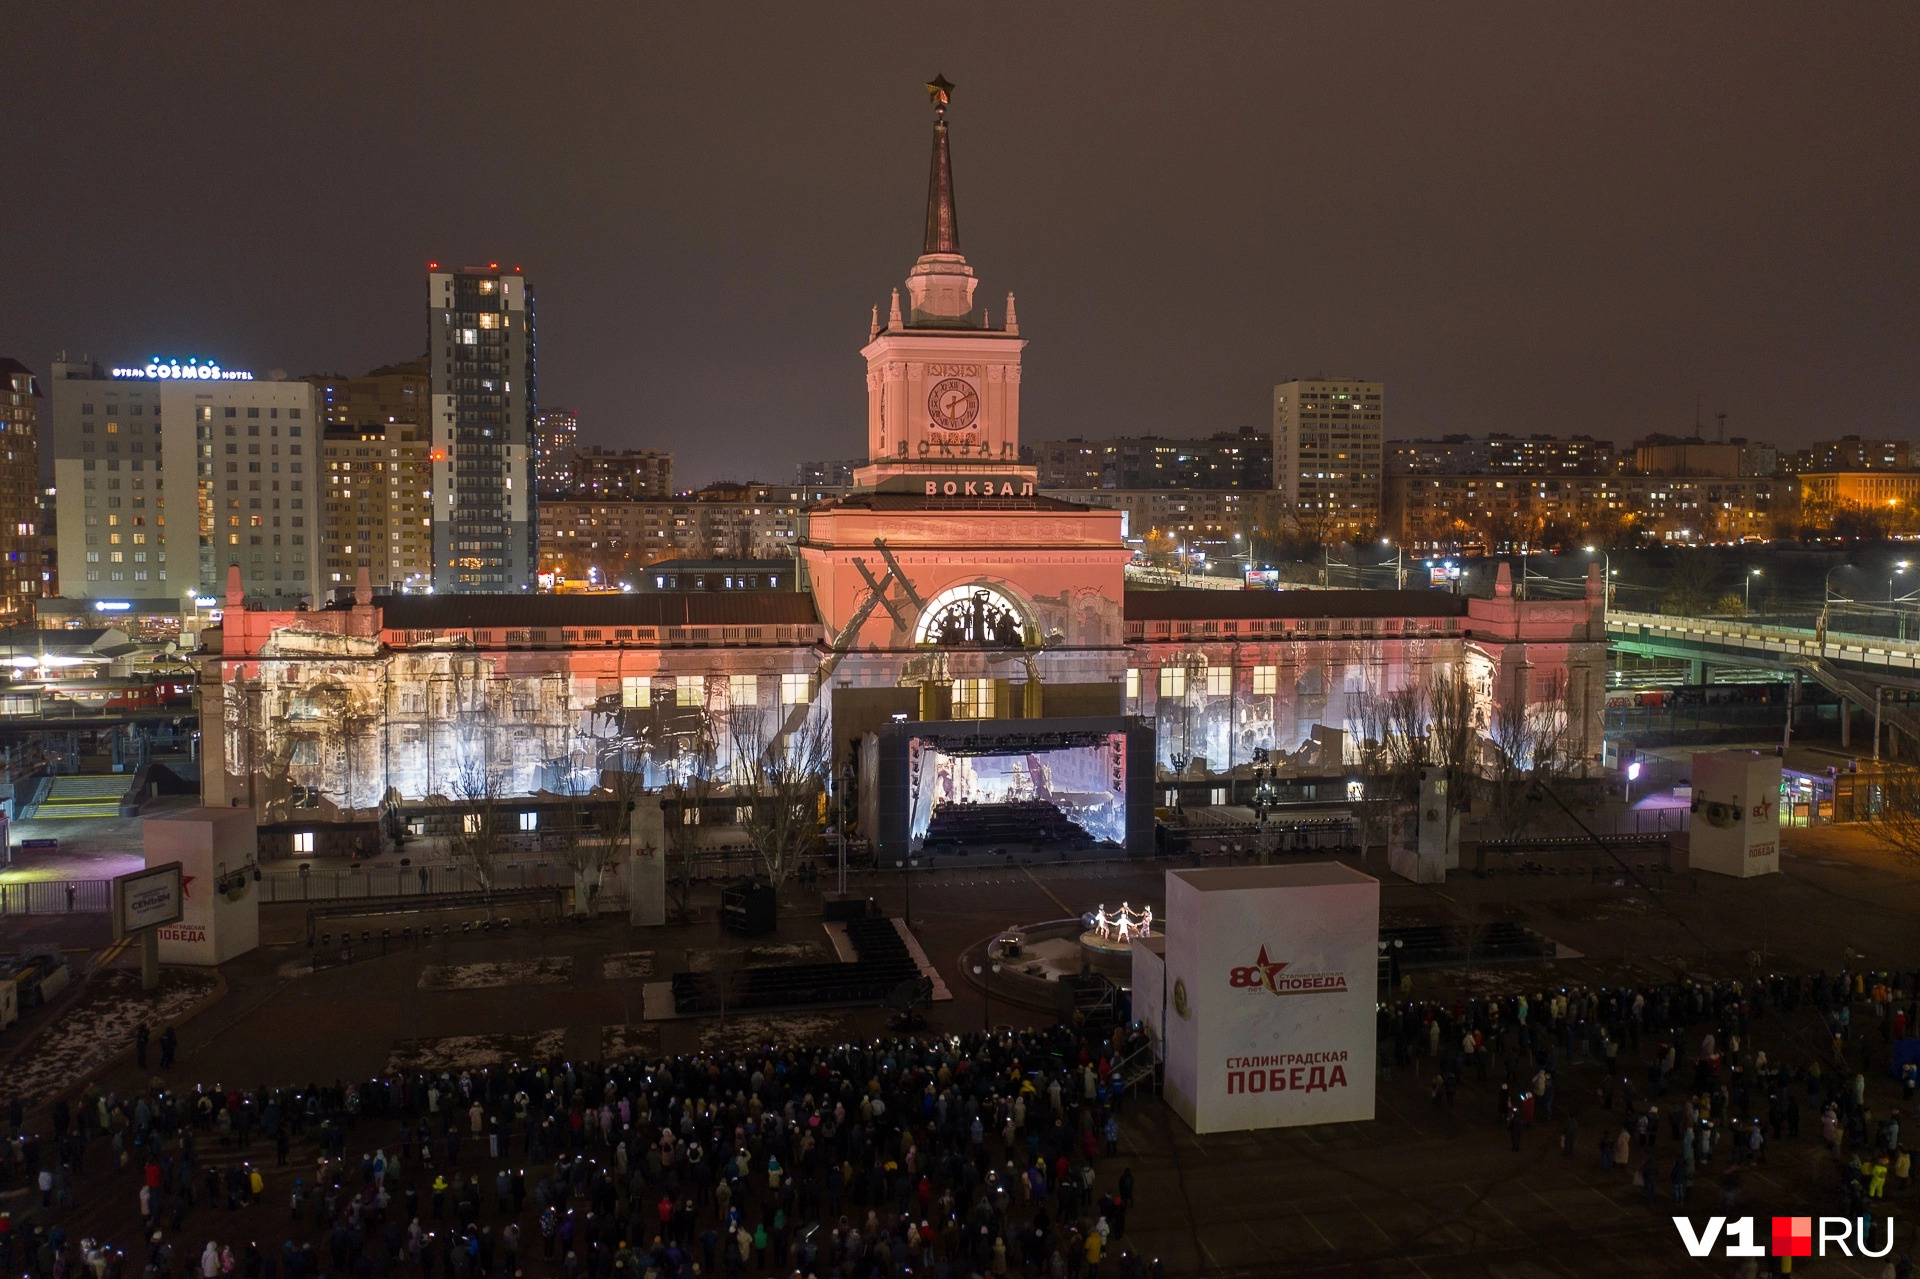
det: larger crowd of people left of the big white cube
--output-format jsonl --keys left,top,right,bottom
{"left": 0, "top": 1026, "right": 1164, "bottom": 1279}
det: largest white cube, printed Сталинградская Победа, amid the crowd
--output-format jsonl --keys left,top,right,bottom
{"left": 1159, "top": 862, "right": 1380, "bottom": 1133}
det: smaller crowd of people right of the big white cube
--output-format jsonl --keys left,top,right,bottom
{"left": 1379, "top": 970, "right": 1920, "bottom": 1218}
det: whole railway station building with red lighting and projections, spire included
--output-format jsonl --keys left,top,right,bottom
{"left": 202, "top": 83, "right": 1605, "bottom": 820}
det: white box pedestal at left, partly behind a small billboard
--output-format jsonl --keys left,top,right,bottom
{"left": 140, "top": 808, "right": 259, "bottom": 964}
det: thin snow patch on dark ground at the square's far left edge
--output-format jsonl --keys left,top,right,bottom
{"left": 0, "top": 968, "right": 217, "bottom": 1106}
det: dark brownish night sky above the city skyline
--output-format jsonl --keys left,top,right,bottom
{"left": 0, "top": 0, "right": 1920, "bottom": 484}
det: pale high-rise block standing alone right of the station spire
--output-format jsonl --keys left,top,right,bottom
{"left": 1273, "top": 378, "right": 1384, "bottom": 536}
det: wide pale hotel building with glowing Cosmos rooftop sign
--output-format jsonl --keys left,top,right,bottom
{"left": 48, "top": 359, "right": 321, "bottom": 613}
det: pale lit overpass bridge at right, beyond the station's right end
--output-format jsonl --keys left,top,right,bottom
{"left": 1607, "top": 609, "right": 1920, "bottom": 757}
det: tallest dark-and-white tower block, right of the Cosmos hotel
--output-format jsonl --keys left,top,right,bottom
{"left": 426, "top": 263, "right": 540, "bottom": 591}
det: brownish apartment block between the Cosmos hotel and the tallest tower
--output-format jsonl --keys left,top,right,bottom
{"left": 307, "top": 357, "right": 434, "bottom": 590}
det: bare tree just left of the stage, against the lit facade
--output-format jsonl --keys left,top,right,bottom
{"left": 728, "top": 707, "right": 833, "bottom": 889}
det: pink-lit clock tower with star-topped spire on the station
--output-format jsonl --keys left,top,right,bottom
{"left": 854, "top": 77, "right": 1029, "bottom": 488}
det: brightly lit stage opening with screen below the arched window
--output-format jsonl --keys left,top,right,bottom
{"left": 906, "top": 734, "right": 1127, "bottom": 849}
